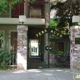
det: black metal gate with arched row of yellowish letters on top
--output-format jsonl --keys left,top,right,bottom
{"left": 36, "top": 28, "right": 70, "bottom": 67}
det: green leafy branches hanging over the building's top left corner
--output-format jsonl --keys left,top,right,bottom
{"left": 0, "top": 0, "right": 36, "bottom": 14}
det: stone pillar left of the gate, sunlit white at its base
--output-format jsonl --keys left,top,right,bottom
{"left": 17, "top": 25, "right": 28, "bottom": 70}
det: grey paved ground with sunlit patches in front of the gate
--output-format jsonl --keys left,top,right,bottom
{"left": 0, "top": 69, "right": 80, "bottom": 80}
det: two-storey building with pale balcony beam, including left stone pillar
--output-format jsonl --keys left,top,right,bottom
{"left": 0, "top": 0, "right": 79, "bottom": 70}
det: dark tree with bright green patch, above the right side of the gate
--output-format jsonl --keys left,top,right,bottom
{"left": 50, "top": 0, "right": 80, "bottom": 33}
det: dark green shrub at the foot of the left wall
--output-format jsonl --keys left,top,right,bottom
{"left": 0, "top": 51, "right": 15, "bottom": 67}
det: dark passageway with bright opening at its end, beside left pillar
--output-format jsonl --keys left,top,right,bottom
{"left": 27, "top": 26, "right": 44, "bottom": 69}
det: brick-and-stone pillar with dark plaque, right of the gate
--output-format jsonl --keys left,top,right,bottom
{"left": 70, "top": 26, "right": 80, "bottom": 69}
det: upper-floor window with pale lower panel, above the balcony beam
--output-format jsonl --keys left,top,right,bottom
{"left": 29, "top": 4, "right": 45, "bottom": 18}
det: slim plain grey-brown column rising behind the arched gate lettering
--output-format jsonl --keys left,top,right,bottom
{"left": 44, "top": 0, "right": 50, "bottom": 64}
